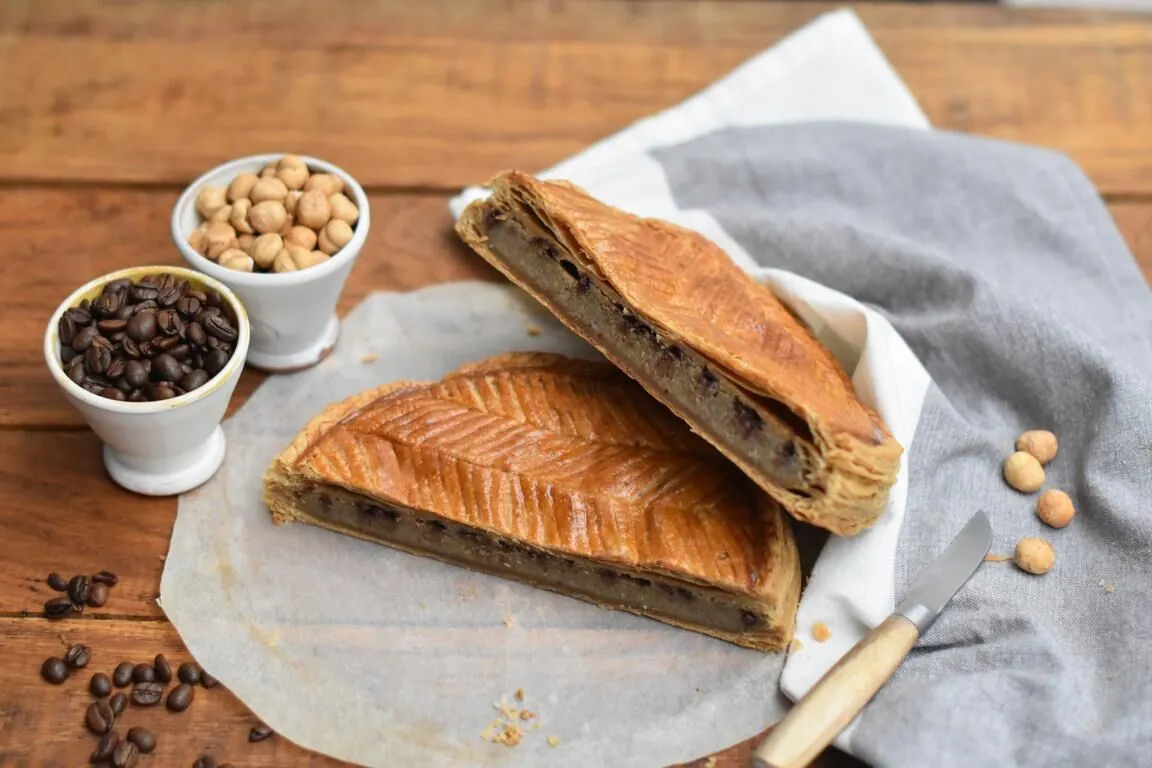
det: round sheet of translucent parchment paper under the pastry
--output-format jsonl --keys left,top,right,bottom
{"left": 160, "top": 282, "right": 786, "bottom": 768}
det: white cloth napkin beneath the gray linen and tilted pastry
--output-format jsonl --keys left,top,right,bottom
{"left": 449, "top": 10, "right": 930, "bottom": 752}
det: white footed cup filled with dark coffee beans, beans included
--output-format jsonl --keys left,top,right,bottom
{"left": 44, "top": 266, "right": 251, "bottom": 496}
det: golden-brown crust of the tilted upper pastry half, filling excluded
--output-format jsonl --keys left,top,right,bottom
{"left": 456, "top": 172, "right": 903, "bottom": 534}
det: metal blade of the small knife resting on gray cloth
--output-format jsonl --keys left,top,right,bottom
{"left": 896, "top": 512, "right": 992, "bottom": 636}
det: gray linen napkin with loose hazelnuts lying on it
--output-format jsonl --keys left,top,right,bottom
{"left": 652, "top": 123, "right": 1152, "bottom": 768}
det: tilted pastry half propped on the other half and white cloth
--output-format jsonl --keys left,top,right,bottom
{"left": 456, "top": 172, "right": 903, "bottom": 534}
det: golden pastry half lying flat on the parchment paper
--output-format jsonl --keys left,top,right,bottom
{"left": 264, "top": 353, "right": 801, "bottom": 649}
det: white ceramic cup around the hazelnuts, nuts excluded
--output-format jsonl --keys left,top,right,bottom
{"left": 172, "top": 152, "right": 371, "bottom": 372}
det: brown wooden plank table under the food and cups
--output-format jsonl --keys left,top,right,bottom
{"left": 0, "top": 0, "right": 1152, "bottom": 768}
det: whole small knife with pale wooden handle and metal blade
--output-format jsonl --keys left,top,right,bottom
{"left": 752, "top": 512, "right": 992, "bottom": 768}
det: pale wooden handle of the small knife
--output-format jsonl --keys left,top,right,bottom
{"left": 752, "top": 615, "right": 919, "bottom": 768}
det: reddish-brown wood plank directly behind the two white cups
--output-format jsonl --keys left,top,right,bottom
{"left": 0, "top": 188, "right": 1152, "bottom": 427}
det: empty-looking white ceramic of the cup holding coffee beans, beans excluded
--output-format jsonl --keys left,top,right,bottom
{"left": 44, "top": 266, "right": 251, "bottom": 496}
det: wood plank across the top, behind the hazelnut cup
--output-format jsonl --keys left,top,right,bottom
{"left": 0, "top": 0, "right": 1152, "bottom": 192}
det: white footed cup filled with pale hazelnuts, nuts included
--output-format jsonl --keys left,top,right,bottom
{"left": 172, "top": 154, "right": 370, "bottom": 372}
